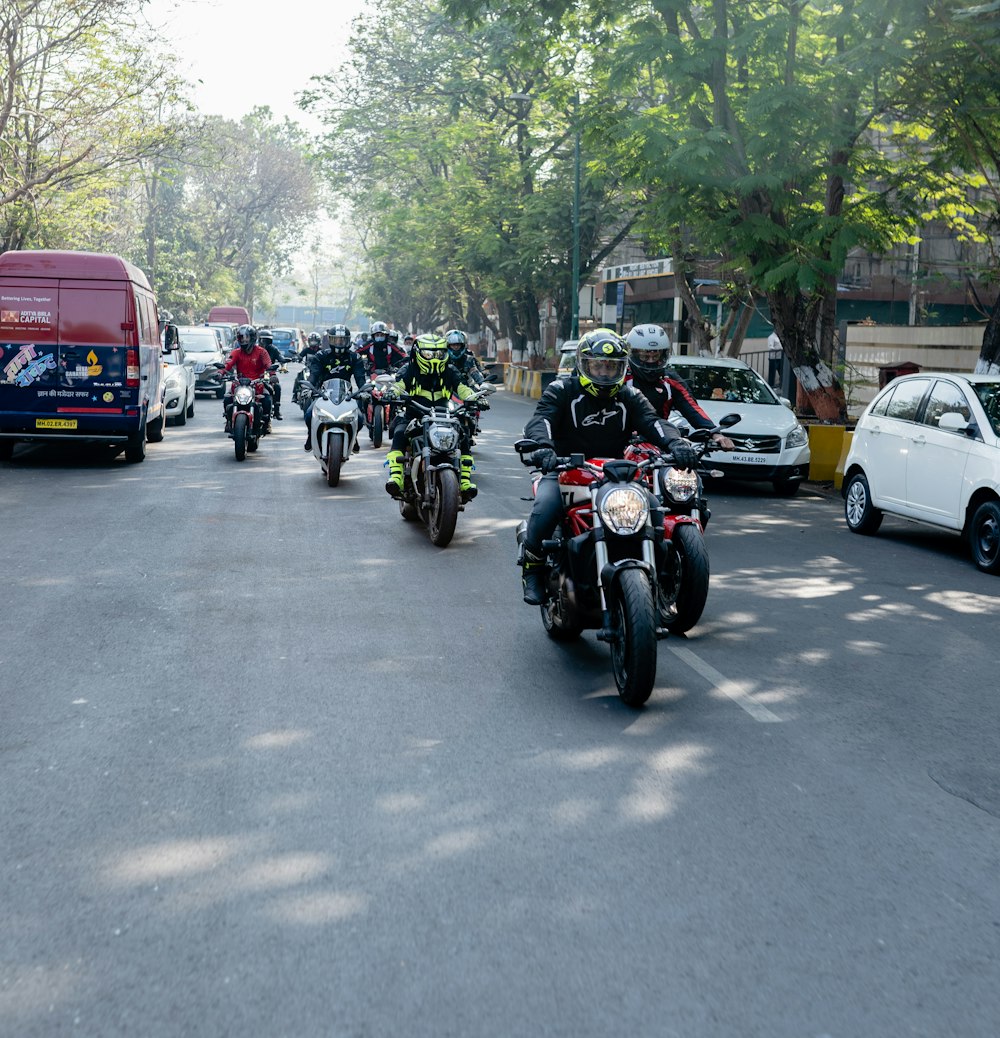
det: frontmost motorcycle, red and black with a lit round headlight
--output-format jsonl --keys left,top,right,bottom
{"left": 514, "top": 439, "right": 701, "bottom": 708}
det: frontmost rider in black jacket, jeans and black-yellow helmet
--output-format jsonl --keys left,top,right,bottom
{"left": 521, "top": 328, "right": 698, "bottom": 605}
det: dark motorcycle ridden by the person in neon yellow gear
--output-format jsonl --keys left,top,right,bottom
{"left": 394, "top": 393, "right": 476, "bottom": 548}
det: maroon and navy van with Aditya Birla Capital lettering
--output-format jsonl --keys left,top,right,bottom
{"left": 0, "top": 250, "right": 164, "bottom": 462}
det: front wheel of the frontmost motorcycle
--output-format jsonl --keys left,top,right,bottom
{"left": 609, "top": 570, "right": 656, "bottom": 708}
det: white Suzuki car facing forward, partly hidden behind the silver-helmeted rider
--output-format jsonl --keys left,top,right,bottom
{"left": 669, "top": 355, "right": 810, "bottom": 497}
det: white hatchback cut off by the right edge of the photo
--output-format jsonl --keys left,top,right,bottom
{"left": 842, "top": 372, "right": 1000, "bottom": 573}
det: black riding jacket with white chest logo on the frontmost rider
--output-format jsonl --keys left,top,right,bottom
{"left": 524, "top": 376, "right": 680, "bottom": 458}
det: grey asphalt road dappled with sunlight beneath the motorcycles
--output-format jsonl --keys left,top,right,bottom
{"left": 0, "top": 376, "right": 1000, "bottom": 1038}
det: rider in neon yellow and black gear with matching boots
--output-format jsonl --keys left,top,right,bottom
{"left": 385, "top": 334, "right": 478, "bottom": 502}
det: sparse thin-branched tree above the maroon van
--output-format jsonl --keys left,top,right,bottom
{"left": 0, "top": 0, "right": 180, "bottom": 248}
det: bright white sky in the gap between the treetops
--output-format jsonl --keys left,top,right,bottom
{"left": 144, "top": 0, "right": 366, "bottom": 132}
